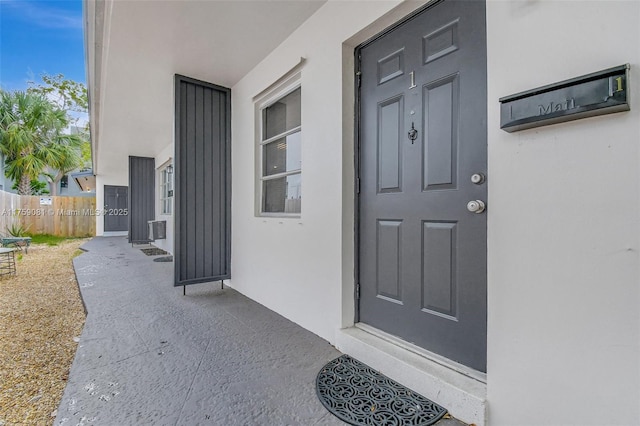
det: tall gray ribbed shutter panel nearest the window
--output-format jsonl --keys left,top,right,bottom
{"left": 174, "top": 75, "right": 231, "bottom": 286}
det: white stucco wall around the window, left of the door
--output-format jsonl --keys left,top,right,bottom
{"left": 231, "top": 1, "right": 419, "bottom": 342}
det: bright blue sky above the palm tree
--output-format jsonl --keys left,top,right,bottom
{"left": 0, "top": 0, "right": 86, "bottom": 90}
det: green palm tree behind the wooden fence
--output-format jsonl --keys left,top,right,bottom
{"left": 0, "top": 91, "right": 82, "bottom": 195}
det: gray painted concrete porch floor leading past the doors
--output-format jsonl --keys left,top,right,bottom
{"left": 54, "top": 237, "right": 462, "bottom": 426}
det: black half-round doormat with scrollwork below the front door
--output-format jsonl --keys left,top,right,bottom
{"left": 316, "top": 355, "right": 447, "bottom": 426}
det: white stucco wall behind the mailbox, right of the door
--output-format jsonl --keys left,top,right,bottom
{"left": 487, "top": 1, "right": 640, "bottom": 425}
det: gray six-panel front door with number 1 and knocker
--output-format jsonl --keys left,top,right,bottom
{"left": 356, "top": 0, "right": 487, "bottom": 371}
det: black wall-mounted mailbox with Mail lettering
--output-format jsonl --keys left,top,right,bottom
{"left": 500, "top": 64, "right": 629, "bottom": 132}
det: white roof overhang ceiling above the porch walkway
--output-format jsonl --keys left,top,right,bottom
{"left": 84, "top": 0, "right": 326, "bottom": 175}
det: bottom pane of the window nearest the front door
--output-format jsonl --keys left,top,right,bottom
{"left": 262, "top": 174, "right": 302, "bottom": 213}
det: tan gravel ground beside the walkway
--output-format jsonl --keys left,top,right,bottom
{"left": 0, "top": 240, "right": 86, "bottom": 426}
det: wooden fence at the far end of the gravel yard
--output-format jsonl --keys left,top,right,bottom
{"left": 0, "top": 191, "right": 99, "bottom": 237}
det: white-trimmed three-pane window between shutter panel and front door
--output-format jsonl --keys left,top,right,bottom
{"left": 260, "top": 86, "right": 302, "bottom": 216}
